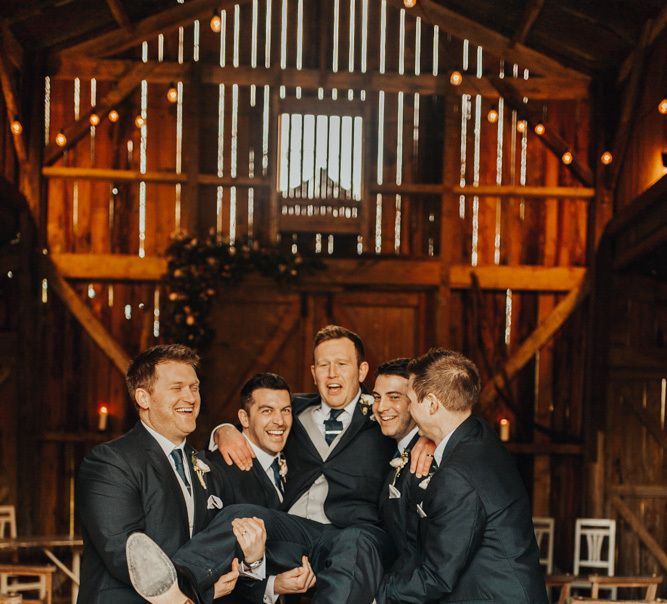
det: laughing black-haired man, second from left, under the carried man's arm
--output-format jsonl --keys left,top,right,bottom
{"left": 207, "top": 373, "right": 315, "bottom": 604}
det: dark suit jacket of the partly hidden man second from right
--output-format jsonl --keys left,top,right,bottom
{"left": 379, "top": 434, "right": 421, "bottom": 568}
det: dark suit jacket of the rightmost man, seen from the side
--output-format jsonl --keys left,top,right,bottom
{"left": 377, "top": 416, "right": 547, "bottom": 604}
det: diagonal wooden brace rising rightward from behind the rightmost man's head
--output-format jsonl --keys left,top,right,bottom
{"left": 479, "top": 279, "right": 589, "bottom": 407}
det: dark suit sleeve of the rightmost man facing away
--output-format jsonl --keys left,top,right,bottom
{"left": 377, "top": 467, "right": 486, "bottom": 604}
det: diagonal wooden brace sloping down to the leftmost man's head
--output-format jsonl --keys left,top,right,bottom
{"left": 44, "top": 259, "right": 130, "bottom": 375}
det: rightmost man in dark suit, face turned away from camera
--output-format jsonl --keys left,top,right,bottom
{"left": 377, "top": 348, "right": 547, "bottom": 604}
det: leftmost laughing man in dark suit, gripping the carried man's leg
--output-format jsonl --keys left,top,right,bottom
{"left": 77, "top": 345, "right": 265, "bottom": 604}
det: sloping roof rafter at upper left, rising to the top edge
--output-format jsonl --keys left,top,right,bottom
{"left": 59, "top": 0, "right": 239, "bottom": 58}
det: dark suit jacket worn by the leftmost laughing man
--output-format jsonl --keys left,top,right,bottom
{"left": 76, "top": 422, "right": 219, "bottom": 604}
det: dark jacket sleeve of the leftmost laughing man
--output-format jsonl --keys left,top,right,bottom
{"left": 77, "top": 445, "right": 145, "bottom": 585}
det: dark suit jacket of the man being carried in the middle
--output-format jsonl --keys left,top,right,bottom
{"left": 283, "top": 395, "right": 395, "bottom": 527}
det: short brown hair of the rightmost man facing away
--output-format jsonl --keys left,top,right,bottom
{"left": 408, "top": 348, "right": 480, "bottom": 411}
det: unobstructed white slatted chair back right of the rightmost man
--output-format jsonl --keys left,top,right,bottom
{"left": 574, "top": 518, "right": 616, "bottom": 576}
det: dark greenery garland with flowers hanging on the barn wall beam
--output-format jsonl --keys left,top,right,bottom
{"left": 161, "top": 233, "right": 325, "bottom": 350}
